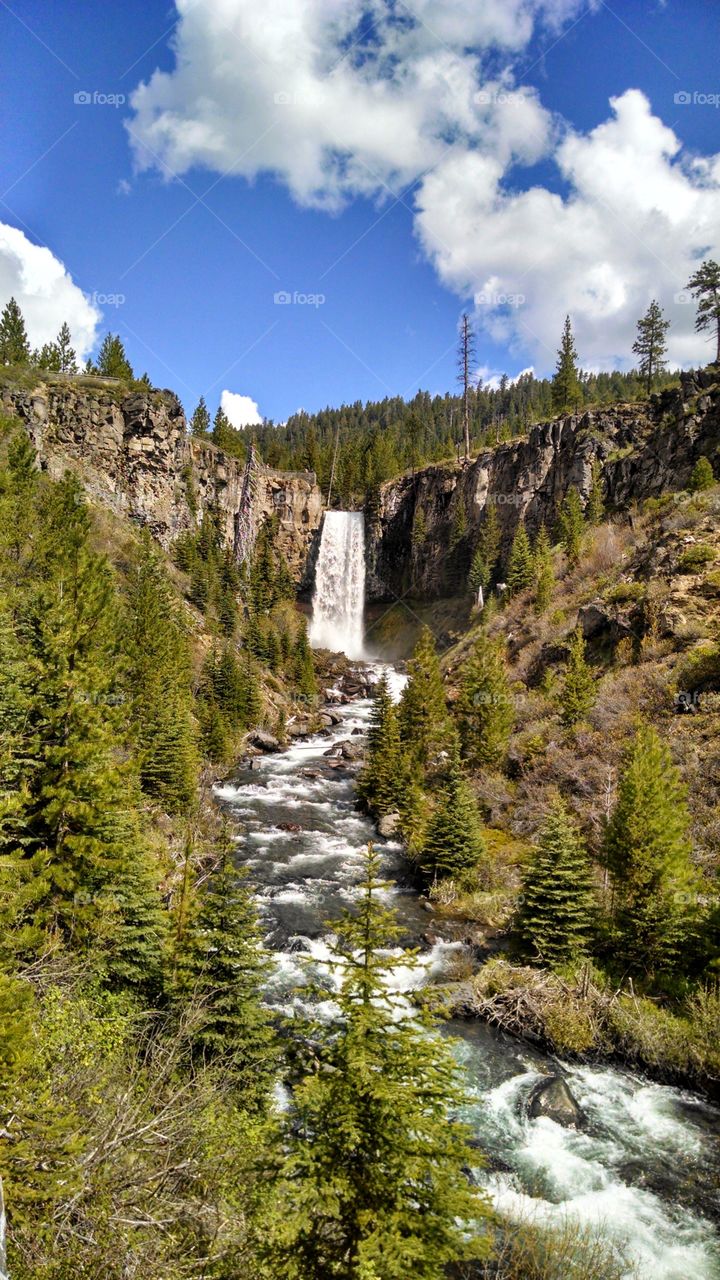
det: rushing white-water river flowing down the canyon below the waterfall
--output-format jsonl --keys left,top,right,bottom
{"left": 218, "top": 686, "right": 720, "bottom": 1280}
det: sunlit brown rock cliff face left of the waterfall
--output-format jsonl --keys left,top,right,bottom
{"left": 0, "top": 378, "right": 323, "bottom": 588}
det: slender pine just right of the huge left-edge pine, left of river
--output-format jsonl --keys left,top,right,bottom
{"left": 127, "top": 532, "right": 197, "bottom": 813}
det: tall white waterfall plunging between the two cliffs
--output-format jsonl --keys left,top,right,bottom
{"left": 310, "top": 511, "right": 365, "bottom": 658}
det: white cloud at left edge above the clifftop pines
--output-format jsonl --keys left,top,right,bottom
{"left": 0, "top": 223, "right": 101, "bottom": 360}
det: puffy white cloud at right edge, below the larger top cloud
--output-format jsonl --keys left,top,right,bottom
{"left": 416, "top": 90, "right": 720, "bottom": 370}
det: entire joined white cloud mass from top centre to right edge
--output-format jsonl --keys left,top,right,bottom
{"left": 128, "top": 0, "right": 720, "bottom": 371}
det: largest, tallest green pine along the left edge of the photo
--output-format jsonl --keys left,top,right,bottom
{"left": 0, "top": 475, "right": 163, "bottom": 983}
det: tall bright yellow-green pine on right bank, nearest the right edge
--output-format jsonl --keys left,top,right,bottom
{"left": 605, "top": 726, "right": 694, "bottom": 974}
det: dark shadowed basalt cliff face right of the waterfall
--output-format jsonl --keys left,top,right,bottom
{"left": 368, "top": 367, "right": 720, "bottom": 600}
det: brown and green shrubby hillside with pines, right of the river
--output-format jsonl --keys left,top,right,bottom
{"left": 364, "top": 460, "right": 720, "bottom": 1091}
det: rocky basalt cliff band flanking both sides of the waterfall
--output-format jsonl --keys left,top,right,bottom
{"left": 0, "top": 366, "right": 720, "bottom": 602}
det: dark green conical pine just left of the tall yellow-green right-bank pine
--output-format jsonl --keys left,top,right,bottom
{"left": 516, "top": 796, "right": 593, "bottom": 968}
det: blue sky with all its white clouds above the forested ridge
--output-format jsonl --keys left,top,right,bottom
{"left": 0, "top": 0, "right": 720, "bottom": 420}
